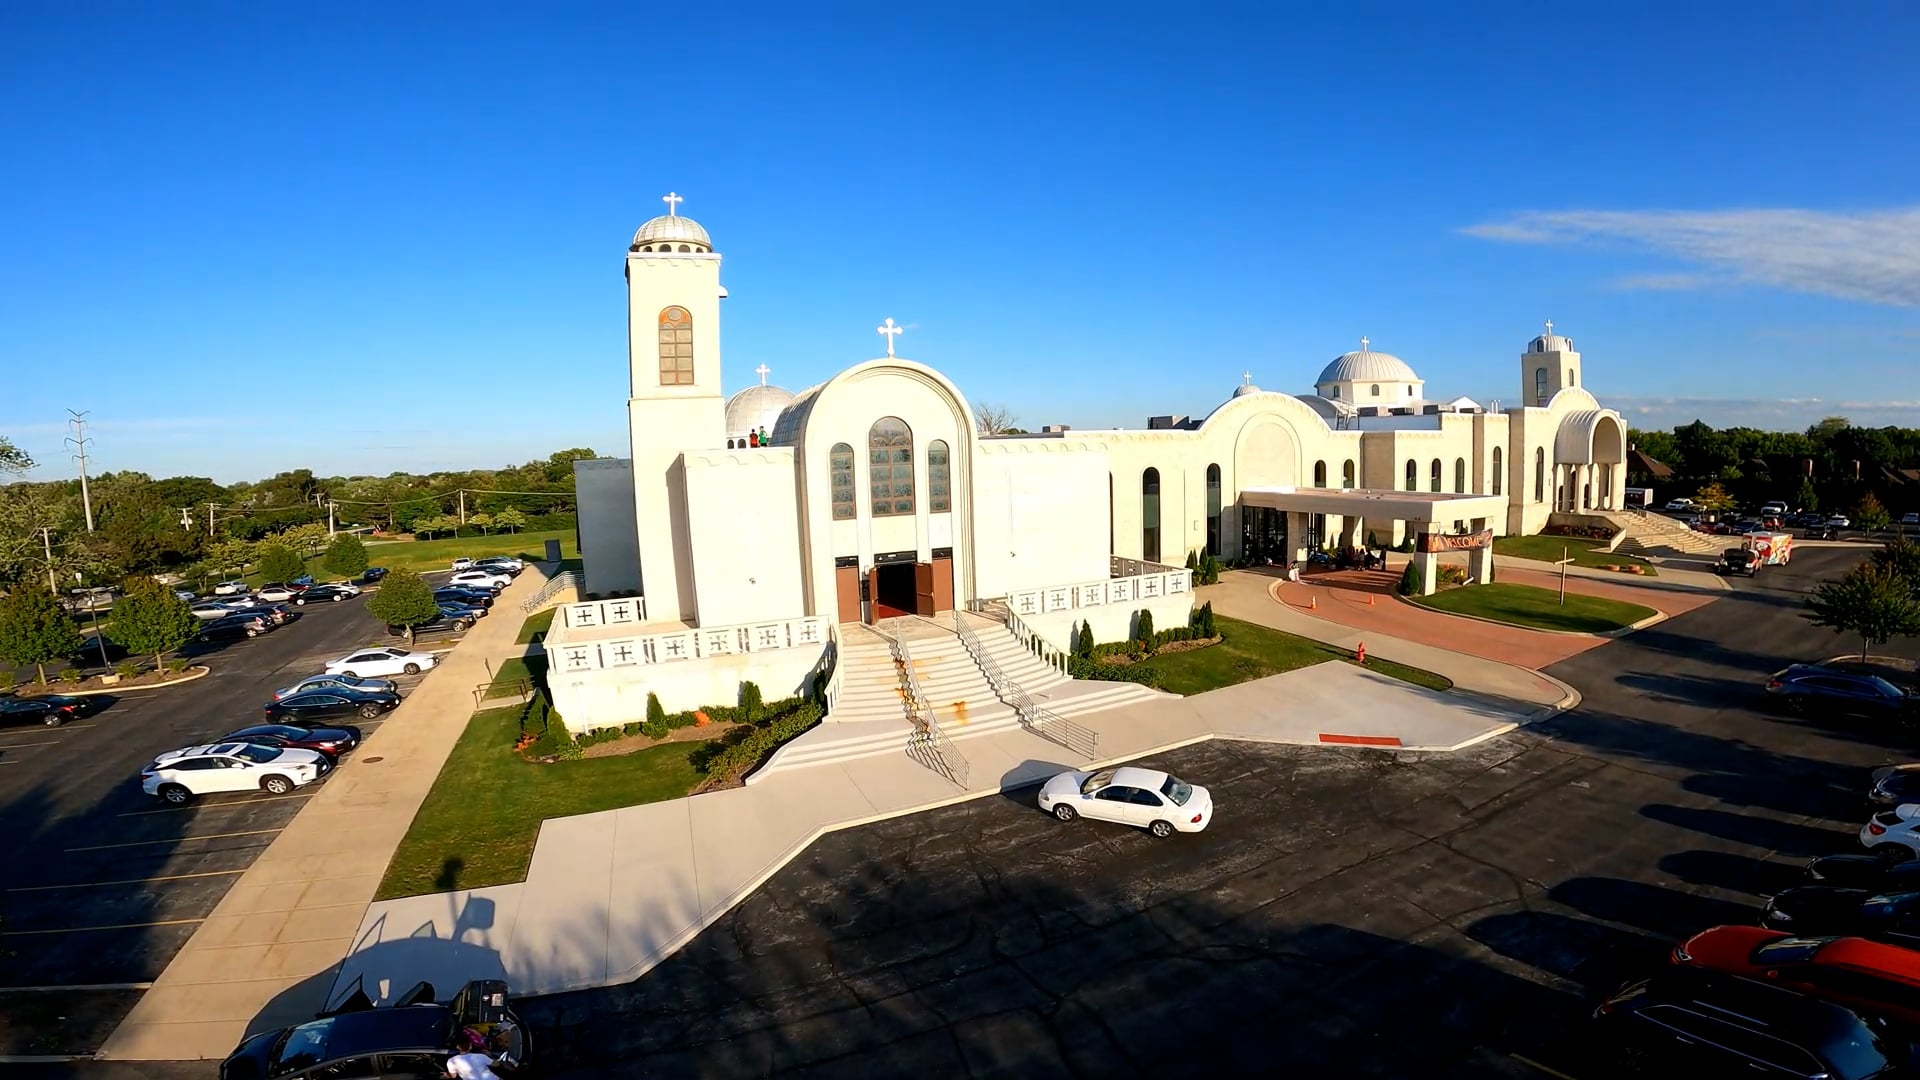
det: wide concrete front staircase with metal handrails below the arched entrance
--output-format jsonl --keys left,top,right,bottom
{"left": 760, "top": 613, "right": 1167, "bottom": 774}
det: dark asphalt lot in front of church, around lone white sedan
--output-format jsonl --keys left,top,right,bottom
{"left": 522, "top": 550, "right": 1914, "bottom": 1080}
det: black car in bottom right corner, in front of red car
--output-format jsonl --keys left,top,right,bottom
{"left": 1594, "top": 967, "right": 1914, "bottom": 1080}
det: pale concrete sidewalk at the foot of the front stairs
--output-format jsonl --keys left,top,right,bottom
{"left": 340, "top": 657, "right": 1528, "bottom": 999}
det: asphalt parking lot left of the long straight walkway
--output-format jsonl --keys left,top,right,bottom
{"left": 0, "top": 580, "right": 476, "bottom": 1053}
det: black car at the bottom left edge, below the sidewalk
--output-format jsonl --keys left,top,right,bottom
{"left": 221, "top": 980, "right": 532, "bottom": 1080}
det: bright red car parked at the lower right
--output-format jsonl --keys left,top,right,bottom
{"left": 1672, "top": 926, "right": 1920, "bottom": 1024}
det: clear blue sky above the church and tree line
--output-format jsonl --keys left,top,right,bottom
{"left": 0, "top": 4, "right": 1920, "bottom": 480}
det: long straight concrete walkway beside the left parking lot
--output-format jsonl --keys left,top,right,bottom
{"left": 98, "top": 567, "right": 560, "bottom": 1061}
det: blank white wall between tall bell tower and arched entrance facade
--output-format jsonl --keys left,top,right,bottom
{"left": 682, "top": 448, "right": 806, "bottom": 626}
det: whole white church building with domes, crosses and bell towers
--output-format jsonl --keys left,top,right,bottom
{"left": 545, "top": 196, "right": 1626, "bottom": 730}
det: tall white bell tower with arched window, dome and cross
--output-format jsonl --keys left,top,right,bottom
{"left": 626, "top": 192, "right": 726, "bottom": 621}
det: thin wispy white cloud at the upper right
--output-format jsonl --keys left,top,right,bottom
{"left": 1463, "top": 208, "right": 1920, "bottom": 307}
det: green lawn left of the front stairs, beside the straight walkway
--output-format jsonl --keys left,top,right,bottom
{"left": 374, "top": 707, "right": 705, "bottom": 899}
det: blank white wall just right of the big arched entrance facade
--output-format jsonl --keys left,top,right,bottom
{"left": 973, "top": 440, "right": 1112, "bottom": 596}
